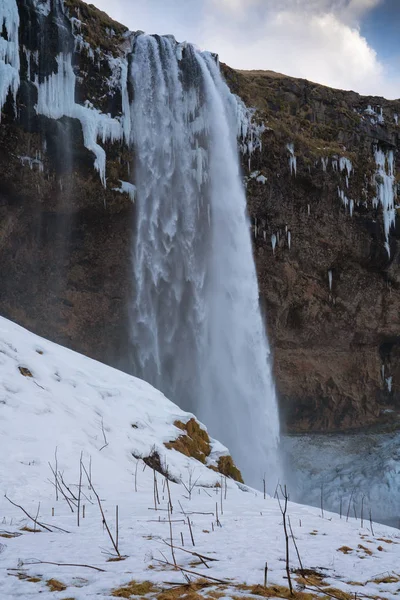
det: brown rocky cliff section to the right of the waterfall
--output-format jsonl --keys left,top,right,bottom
{"left": 225, "top": 68, "right": 400, "bottom": 431}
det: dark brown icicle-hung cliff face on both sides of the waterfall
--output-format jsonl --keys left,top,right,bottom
{"left": 0, "top": 0, "right": 400, "bottom": 430}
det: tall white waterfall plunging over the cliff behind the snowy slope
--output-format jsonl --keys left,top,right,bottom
{"left": 130, "top": 34, "right": 279, "bottom": 489}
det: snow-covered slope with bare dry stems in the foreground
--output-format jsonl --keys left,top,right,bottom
{"left": 0, "top": 319, "right": 400, "bottom": 600}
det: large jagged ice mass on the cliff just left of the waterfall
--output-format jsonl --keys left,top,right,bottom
{"left": 35, "top": 54, "right": 124, "bottom": 187}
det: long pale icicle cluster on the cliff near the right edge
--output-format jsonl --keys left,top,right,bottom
{"left": 375, "top": 149, "right": 397, "bottom": 256}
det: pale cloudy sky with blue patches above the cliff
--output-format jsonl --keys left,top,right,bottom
{"left": 92, "top": 0, "right": 400, "bottom": 99}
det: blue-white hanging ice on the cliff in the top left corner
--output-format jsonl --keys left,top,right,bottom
{"left": 0, "top": 0, "right": 20, "bottom": 121}
